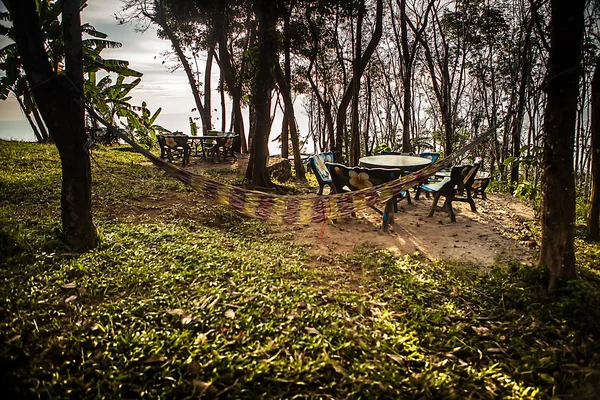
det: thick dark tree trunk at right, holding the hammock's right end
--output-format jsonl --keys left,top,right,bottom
{"left": 539, "top": 0, "right": 585, "bottom": 292}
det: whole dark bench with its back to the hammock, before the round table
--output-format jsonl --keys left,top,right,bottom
{"left": 325, "top": 163, "right": 411, "bottom": 232}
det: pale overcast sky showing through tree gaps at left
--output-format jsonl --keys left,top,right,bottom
{"left": 0, "top": 0, "right": 307, "bottom": 150}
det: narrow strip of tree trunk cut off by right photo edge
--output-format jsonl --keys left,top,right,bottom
{"left": 587, "top": 57, "right": 600, "bottom": 240}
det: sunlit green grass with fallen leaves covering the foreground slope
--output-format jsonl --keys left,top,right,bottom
{"left": 0, "top": 142, "right": 600, "bottom": 399}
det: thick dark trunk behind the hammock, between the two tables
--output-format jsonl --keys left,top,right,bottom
{"left": 246, "top": 0, "right": 277, "bottom": 187}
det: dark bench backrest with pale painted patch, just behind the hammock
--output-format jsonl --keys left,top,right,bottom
{"left": 326, "top": 163, "right": 401, "bottom": 193}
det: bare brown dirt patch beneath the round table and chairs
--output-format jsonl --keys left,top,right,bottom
{"left": 187, "top": 157, "right": 537, "bottom": 266}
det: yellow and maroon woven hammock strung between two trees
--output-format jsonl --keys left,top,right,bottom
{"left": 86, "top": 106, "right": 507, "bottom": 225}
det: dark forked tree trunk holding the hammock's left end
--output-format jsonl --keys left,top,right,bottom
{"left": 4, "top": 0, "right": 97, "bottom": 251}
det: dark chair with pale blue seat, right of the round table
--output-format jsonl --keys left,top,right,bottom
{"left": 415, "top": 164, "right": 479, "bottom": 222}
